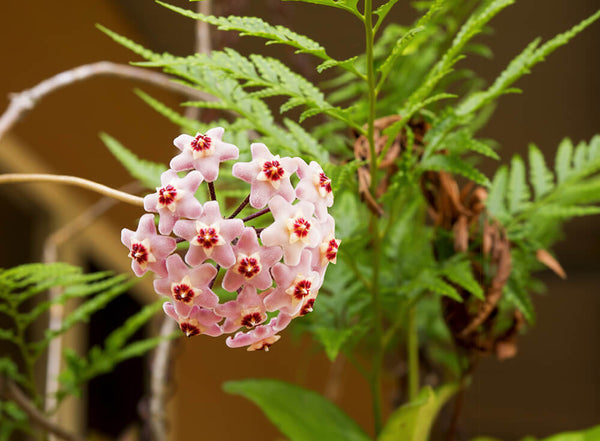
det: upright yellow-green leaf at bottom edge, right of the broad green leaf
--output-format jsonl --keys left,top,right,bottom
{"left": 377, "top": 384, "right": 458, "bottom": 441}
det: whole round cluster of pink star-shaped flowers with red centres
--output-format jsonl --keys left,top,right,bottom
{"left": 121, "top": 127, "right": 340, "bottom": 350}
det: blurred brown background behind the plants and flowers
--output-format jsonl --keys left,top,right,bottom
{"left": 0, "top": 0, "right": 600, "bottom": 441}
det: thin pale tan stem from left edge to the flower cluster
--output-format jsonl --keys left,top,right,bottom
{"left": 0, "top": 173, "right": 144, "bottom": 207}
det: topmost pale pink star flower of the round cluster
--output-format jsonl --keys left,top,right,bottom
{"left": 170, "top": 127, "right": 239, "bottom": 182}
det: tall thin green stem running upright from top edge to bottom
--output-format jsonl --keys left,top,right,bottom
{"left": 364, "top": 0, "right": 384, "bottom": 436}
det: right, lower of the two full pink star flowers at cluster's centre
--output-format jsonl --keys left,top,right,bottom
{"left": 223, "top": 228, "right": 282, "bottom": 292}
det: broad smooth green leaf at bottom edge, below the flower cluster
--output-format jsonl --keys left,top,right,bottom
{"left": 223, "top": 379, "right": 370, "bottom": 441}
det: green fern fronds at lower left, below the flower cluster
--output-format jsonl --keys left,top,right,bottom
{"left": 0, "top": 263, "right": 162, "bottom": 408}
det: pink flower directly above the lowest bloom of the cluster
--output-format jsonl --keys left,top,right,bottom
{"left": 215, "top": 285, "right": 267, "bottom": 334}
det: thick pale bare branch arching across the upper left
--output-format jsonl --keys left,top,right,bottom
{"left": 0, "top": 61, "right": 216, "bottom": 139}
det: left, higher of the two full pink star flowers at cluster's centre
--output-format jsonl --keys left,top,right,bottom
{"left": 173, "top": 201, "right": 244, "bottom": 268}
